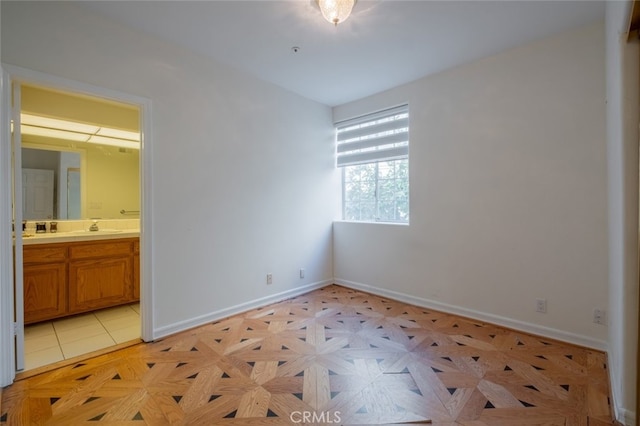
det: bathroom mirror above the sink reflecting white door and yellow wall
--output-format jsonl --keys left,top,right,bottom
{"left": 22, "top": 145, "right": 140, "bottom": 220}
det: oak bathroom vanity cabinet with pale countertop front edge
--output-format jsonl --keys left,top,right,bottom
{"left": 23, "top": 232, "right": 140, "bottom": 324}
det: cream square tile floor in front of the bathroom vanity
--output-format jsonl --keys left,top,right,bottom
{"left": 24, "top": 303, "right": 140, "bottom": 370}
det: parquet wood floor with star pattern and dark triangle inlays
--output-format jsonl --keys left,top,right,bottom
{"left": 0, "top": 285, "right": 613, "bottom": 426}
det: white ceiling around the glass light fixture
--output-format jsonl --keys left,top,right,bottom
{"left": 75, "top": 0, "right": 605, "bottom": 106}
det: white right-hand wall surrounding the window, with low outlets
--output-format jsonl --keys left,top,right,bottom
{"left": 334, "top": 23, "right": 608, "bottom": 349}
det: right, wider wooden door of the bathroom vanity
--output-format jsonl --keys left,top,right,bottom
{"left": 69, "top": 256, "right": 133, "bottom": 313}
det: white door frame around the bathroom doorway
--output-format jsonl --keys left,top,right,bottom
{"left": 0, "top": 64, "right": 155, "bottom": 386}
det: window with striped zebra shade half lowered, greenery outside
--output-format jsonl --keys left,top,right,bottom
{"left": 336, "top": 105, "right": 409, "bottom": 223}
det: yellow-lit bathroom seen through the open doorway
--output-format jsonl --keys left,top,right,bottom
{"left": 14, "top": 84, "right": 141, "bottom": 371}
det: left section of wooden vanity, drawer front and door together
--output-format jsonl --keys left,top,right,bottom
{"left": 23, "top": 244, "right": 67, "bottom": 324}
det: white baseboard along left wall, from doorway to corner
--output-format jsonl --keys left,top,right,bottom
{"left": 154, "top": 280, "right": 333, "bottom": 339}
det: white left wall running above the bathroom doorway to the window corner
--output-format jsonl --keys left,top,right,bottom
{"left": 1, "top": 2, "right": 339, "bottom": 336}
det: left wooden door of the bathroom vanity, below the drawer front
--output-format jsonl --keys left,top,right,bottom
{"left": 23, "top": 263, "right": 67, "bottom": 324}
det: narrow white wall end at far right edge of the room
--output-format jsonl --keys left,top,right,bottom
{"left": 606, "top": 1, "right": 640, "bottom": 425}
